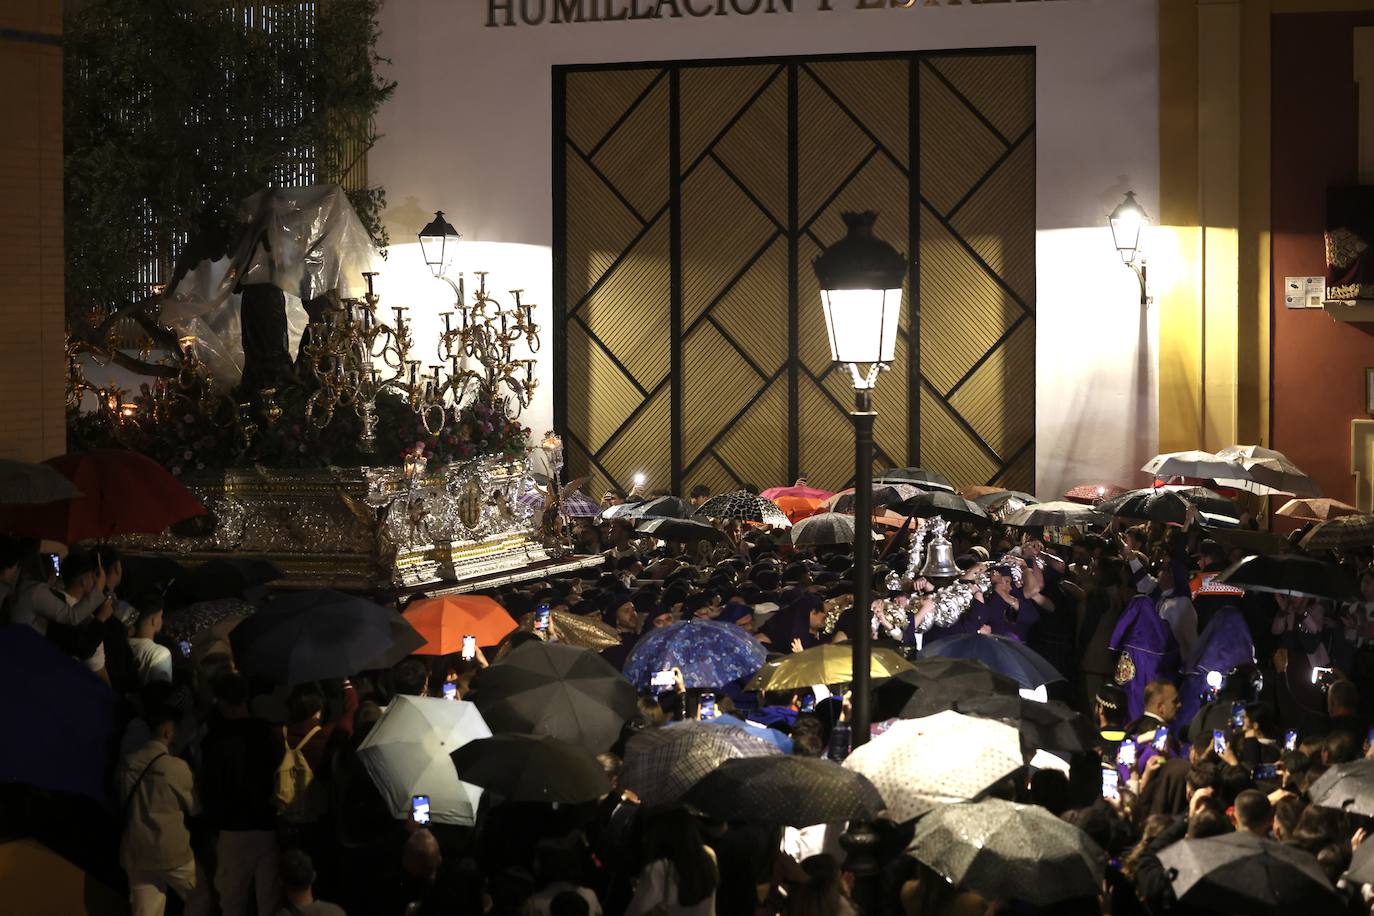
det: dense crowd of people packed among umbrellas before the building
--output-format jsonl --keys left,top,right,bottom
{"left": 0, "top": 477, "right": 1374, "bottom": 916}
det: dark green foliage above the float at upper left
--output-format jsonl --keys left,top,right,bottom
{"left": 63, "top": 0, "right": 394, "bottom": 322}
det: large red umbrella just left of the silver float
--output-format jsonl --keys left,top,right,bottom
{"left": 5, "top": 449, "right": 205, "bottom": 544}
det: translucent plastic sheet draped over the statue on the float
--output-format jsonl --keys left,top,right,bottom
{"left": 161, "top": 184, "right": 376, "bottom": 393}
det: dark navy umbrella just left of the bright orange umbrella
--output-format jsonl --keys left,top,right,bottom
{"left": 229, "top": 589, "right": 392, "bottom": 684}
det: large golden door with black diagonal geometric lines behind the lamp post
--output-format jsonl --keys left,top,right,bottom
{"left": 554, "top": 49, "right": 1035, "bottom": 492}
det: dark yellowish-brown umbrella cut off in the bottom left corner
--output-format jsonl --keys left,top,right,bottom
{"left": 0, "top": 839, "right": 129, "bottom": 916}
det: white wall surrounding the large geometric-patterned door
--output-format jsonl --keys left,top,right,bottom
{"left": 368, "top": 0, "right": 1158, "bottom": 497}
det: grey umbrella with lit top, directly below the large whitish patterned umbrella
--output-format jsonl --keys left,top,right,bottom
{"left": 907, "top": 798, "right": 1106, "bottom": 906}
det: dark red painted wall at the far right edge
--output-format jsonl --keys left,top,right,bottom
{"left": 1271, "top": 12, "right": 1374, "bottom": 501}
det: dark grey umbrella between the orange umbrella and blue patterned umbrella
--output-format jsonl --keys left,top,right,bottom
{"left": 475, "top": 643, "right": 639, "bottom": 754}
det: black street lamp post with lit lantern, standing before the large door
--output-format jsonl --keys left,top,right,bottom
{"left": 813, "top": 211, "right": 907, "bottom": 744}
